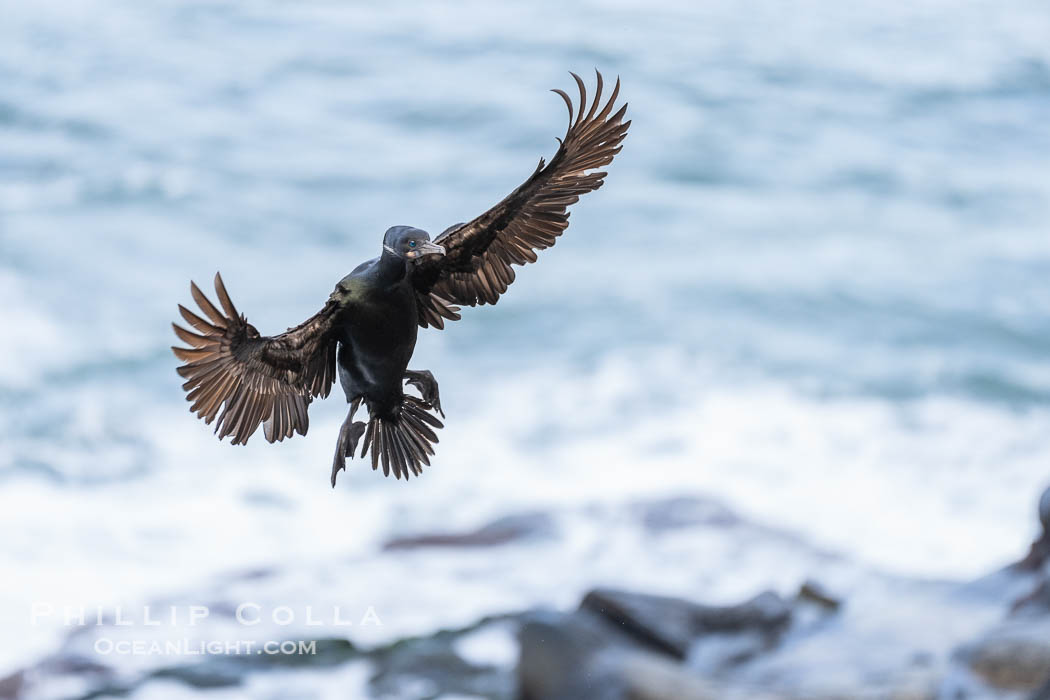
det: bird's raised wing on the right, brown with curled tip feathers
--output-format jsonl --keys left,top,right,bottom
{"left": 413, "top": 71, "right": 631, "bottom": 328}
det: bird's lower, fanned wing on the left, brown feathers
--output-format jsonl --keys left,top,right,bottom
{"left": 171, "top": 273, "right": 339, "bottom": 445}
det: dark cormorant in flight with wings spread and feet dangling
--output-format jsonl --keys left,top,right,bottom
{"left": 172, "top": 71, "right": 631, "bottom": 486}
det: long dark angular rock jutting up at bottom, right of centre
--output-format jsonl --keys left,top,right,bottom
{"left": 580, "top": 590, "right": 791, "bottom": 659}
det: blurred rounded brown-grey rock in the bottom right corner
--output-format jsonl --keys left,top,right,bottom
{"left": 962, "top": 616, "right": 1050, "bottom": 691}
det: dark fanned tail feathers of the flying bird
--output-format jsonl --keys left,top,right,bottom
{"left": 361, "top": 395, "right": 444, "bottom": 480}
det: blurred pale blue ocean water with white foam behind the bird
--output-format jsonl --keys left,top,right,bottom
{"left": 0, "top": 0, "right": 1050, "bottom": 697}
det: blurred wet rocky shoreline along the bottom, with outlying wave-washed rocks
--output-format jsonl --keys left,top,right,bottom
{"left": 8, "top": 489, "right": 1050, "bottom": 700}
